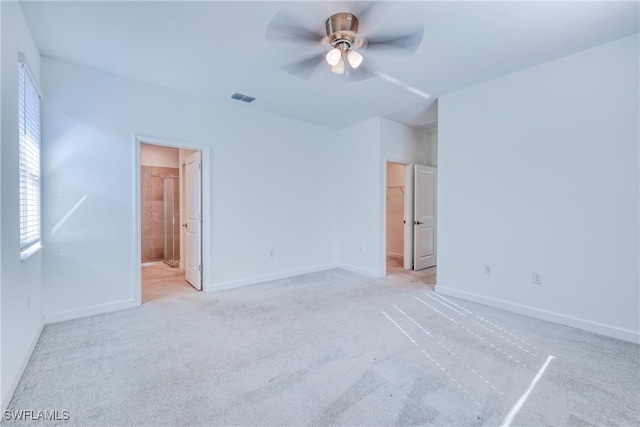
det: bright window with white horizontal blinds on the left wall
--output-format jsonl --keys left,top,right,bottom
{"left": 18, "top": 55, "right": 41, "bottom": 254}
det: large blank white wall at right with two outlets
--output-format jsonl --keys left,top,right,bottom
{"left": 437, "top": 35, "right": 640, "bottom": 342}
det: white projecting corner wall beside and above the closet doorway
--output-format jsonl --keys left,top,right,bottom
{"left": 336, "top": 118, "right": 430, "bottom": 277}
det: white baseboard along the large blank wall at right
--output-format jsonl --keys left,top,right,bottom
{"left": 436, "top": 285, "right": 640, "bottom": 344}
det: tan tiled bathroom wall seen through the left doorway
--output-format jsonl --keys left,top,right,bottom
{"left": 141, "top": 166, "right": 180, "bottom": 262}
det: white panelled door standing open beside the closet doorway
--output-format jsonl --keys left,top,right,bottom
{"left": 413, "top": 165, "right": 437, "bottom": 270}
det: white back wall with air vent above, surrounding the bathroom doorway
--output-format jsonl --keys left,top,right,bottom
{"left": 42, "top": 58, "right": 337, "bottom": 318}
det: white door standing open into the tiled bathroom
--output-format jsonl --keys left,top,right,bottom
{"left": 185, "top": 151, "right": 202, "bottom": 290}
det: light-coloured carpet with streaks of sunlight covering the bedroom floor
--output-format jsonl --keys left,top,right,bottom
{"left": 3, "top": 269, "right": 640, "bottom": 426}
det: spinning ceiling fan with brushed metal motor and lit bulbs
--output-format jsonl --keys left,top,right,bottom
{"left": 265, "top": 3, "right": 423, "bottom": 81}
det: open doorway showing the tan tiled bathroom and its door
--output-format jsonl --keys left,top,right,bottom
{"left": 138, "top": 138, "right": 203, "bottom": 303}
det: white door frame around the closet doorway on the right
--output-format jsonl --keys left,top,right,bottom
{"left": 381, "top": 157, "right": 414, "bottom": 276}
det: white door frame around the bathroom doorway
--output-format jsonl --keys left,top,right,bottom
{"left": 133, "top": 135, "right": 212, "bottom": 305}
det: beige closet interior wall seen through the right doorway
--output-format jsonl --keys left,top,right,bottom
{"left": 386, "top": 162, "right": 405, "bottom": 257}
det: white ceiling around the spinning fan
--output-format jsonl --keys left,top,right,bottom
{"left": 22, "top": 1, "right": 640, "bottom": 128}
